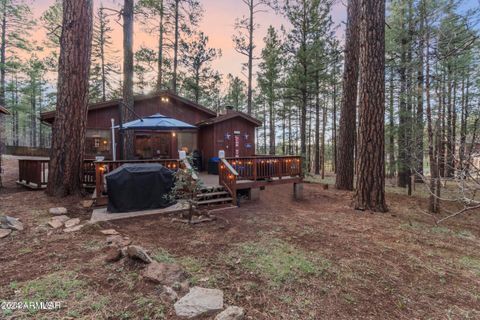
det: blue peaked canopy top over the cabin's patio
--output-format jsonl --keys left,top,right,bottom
{"left": 115, "top": 113, "right": 197, "bottom": 130}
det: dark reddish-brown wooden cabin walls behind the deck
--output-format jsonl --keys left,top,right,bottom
{"left": 41, "top": 91, "right": 261, "bottom": 168}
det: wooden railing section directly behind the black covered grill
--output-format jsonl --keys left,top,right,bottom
{"left": 94, "top": 159, "right": 182, "bottom": 199}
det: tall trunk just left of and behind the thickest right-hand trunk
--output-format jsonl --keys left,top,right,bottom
{"left": 335, "top": 0, "right": 360, "bottom": 190}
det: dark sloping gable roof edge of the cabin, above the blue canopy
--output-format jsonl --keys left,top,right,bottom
{"left": 40, "top": 90, "right": 217, "bottom": 121}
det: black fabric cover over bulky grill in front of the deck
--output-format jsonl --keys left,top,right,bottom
{"left": 105, "top": 163, "right": 175, "bottom": 213}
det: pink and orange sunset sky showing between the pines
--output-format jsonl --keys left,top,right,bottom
{"left": 33, "top": 0, "right": 346, "bottom": 84}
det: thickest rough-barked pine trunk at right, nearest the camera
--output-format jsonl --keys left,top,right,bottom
{"left": 355, "top": 0, "right": 387, "bottom": 212}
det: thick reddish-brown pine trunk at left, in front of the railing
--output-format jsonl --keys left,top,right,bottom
{"left": 47, "top": 0, "right": 93, "bottom": 197}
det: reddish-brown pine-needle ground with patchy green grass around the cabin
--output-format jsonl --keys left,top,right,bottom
{"left": 0, "top": 154, "right": 480, "bottom": 320}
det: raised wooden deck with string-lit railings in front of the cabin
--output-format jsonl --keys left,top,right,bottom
{"left": 17, "top": 156, "right": 303, "bottom": 205}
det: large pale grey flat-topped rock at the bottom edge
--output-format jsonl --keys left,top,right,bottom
{"left": 174, "top": 287, "right": 223, "bottom": 318}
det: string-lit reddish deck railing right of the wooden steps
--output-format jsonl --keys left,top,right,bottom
{"left": 218, "top": 156, "right": 302, "bottom": 199}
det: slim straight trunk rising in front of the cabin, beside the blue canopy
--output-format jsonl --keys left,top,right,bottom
{"left": 121, "top": 0, "right": 134, "bottom": 159}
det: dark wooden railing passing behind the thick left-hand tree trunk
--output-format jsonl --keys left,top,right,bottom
{"left": 18, "top": 159, "right": 95, "bottom": 189}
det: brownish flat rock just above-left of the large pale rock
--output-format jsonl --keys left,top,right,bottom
{"left": 142, "top": 261, "right": 187, "bottom": 286}
